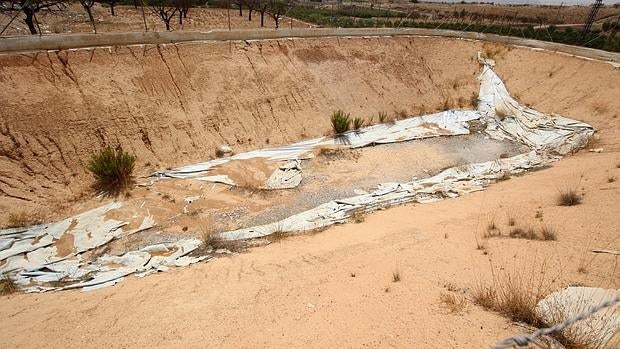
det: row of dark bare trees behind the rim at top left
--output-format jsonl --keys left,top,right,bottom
{"left": 0, "top": 0, "right": 292, "bottom": 34}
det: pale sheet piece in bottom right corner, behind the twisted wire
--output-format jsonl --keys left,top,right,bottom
{"left": 536, "top": 287, "right": 620, "bottom": 349}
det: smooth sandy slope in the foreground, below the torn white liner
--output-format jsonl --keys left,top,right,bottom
{"left": 0, "top": 152, "right": 620, "bottom": 348}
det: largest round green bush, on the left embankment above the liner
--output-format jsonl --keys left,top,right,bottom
{"left": 87, "top": 146, "right": 136, "bottom": 193}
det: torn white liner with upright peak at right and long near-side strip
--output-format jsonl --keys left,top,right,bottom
{"left": 216, "top": 59, "right": 594, "bottom": 240}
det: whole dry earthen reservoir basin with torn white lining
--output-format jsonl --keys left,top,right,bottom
{"left": 0, "top": 17, "right": 620, "bottom": 348}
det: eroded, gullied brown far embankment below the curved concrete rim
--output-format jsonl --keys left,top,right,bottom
{"left": 0, "top": 37, "right": 620, "bottom": 222}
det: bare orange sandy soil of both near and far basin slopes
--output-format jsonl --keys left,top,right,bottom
{"left": 0, "top": 38, "right": 620, "bottom": 348}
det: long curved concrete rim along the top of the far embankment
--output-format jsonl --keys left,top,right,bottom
{"left": 0, "top": 28, "right": 620, "bottom": 63}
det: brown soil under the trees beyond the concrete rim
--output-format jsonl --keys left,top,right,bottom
{"left": 0, "top": 3, "right": 308, "bottom": 36}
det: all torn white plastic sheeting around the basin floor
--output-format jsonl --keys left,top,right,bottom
{"left": 0, "top": 61, "right": 594, "bottom": 292}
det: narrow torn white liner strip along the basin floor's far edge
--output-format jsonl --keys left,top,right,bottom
{"left": 151, "top": 110, "right": 480, "bottom": 179}
